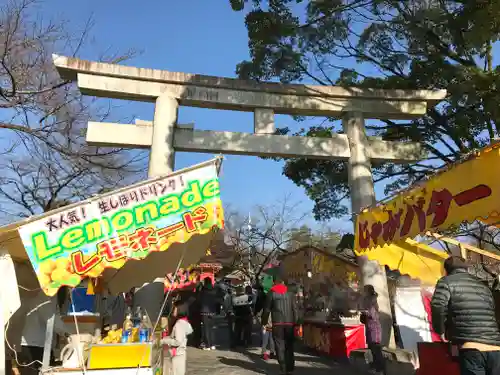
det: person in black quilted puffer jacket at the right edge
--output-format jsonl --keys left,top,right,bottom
{"left": 431, "top": 256, "right": 500, "bottom": 375}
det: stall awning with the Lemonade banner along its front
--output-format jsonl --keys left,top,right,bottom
{"left": 0, "top": 158, "right": 224, "bottom": 295}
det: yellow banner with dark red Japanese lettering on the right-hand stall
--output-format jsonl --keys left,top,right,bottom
{"left": 355, "top": 145, "right": 500, "bottom": 255}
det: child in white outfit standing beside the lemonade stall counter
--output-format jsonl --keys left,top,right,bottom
{"left": 161, "top": 305, "right": 193, "bottom": 375}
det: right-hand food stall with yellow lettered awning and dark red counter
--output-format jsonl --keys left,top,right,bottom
{"left": 355, "top": 143, "right": 500, "bottom": 375}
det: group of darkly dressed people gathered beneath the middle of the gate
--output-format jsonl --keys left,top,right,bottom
{"left": 164, "top": 277, "right": 300, "bottom": 374}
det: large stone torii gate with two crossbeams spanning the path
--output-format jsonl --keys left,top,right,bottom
{"left": 53, "top": 55, "right": 446, "bottom": 345}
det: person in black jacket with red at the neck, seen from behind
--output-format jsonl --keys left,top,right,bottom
{"left": 262, "top": 276, "right": 298, "bottom": 375}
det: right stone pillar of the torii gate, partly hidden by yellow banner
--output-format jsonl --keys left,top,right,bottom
{"left": 342, "top": 112, "right": 395, "bottom": 347}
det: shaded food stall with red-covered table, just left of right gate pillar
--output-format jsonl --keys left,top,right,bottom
{"left": 280, "top": 246, "right": 366, "bottom": 359}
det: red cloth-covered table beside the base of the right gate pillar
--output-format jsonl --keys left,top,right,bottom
{"left": 303, "top": 321, "right": 366, "bottom": 358}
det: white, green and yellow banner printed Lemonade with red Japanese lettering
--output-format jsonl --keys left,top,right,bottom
{"left": 19, "top": 162, "right": 224, "bottom": 296}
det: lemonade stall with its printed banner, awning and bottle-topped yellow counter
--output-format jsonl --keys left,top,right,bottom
{"left": 0, "top": 158, "right": 224, "bottom": 375}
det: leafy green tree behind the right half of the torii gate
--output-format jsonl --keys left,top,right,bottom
{"left": 231, "top": 0, "right": 500, "bottom": 219}
